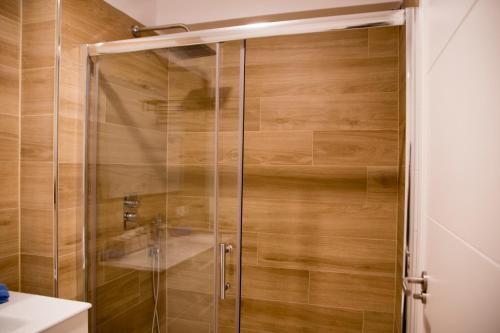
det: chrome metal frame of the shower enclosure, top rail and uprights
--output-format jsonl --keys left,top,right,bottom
{"left": 83, "top": 9, "right": 414, "bottom": 332}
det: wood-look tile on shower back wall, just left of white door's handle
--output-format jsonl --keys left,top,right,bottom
{"left": 309, "top": 272, "right": 394, "bottom": 315}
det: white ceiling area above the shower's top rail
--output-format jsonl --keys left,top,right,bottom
{"left": 105, "top": 0, "right": 400, "bottom": 25}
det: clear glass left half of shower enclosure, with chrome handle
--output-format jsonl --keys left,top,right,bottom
{"left": 86, "top": 43, "right": 241, "bottom": 332}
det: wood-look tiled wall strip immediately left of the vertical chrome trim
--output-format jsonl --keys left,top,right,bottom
{"left": 20, "top": 0, "right": 56, "bottom": 295}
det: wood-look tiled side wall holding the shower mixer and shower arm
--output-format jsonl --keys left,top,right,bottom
{"left": 59, "top": 0, "right": 172, "bottom": 332}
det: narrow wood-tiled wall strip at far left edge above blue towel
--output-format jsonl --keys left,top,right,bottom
{"left": 0, "top": 0, "right": 21, "bottom": 290}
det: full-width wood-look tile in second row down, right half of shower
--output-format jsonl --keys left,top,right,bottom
{"left": 245, "top": 57, "right": 398, "bottom": 97}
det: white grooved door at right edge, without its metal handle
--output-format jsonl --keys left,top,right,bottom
{"left": 419, "top": 0, "right": 500, "bottom": 333}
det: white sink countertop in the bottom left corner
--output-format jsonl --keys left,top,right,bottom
{"left": 0, "top": 292, "right": 91, "bottom": 333}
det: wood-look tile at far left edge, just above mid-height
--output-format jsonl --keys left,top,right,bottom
{"left": 0, "top": 114, "right": 19, "bottom": 162}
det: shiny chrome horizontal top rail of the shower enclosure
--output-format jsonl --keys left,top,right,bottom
{"left": 87, "top": 9, "right": 405, "bottom": 56}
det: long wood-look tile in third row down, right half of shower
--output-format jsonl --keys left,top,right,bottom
{"left": 260, "top": 92, "right": 398, "bottom": 131}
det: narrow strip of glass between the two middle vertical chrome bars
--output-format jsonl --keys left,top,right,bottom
{"left": 217, "top": 41, "right": 244, "bottom": 332}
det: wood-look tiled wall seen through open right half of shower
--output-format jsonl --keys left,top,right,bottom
{"left": 241, "top": 28, "right": 400, "bottom": 332}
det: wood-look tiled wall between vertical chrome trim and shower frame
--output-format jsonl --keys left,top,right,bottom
{"left": 58, "top": 0, "right": 147, "bottom": 299}
